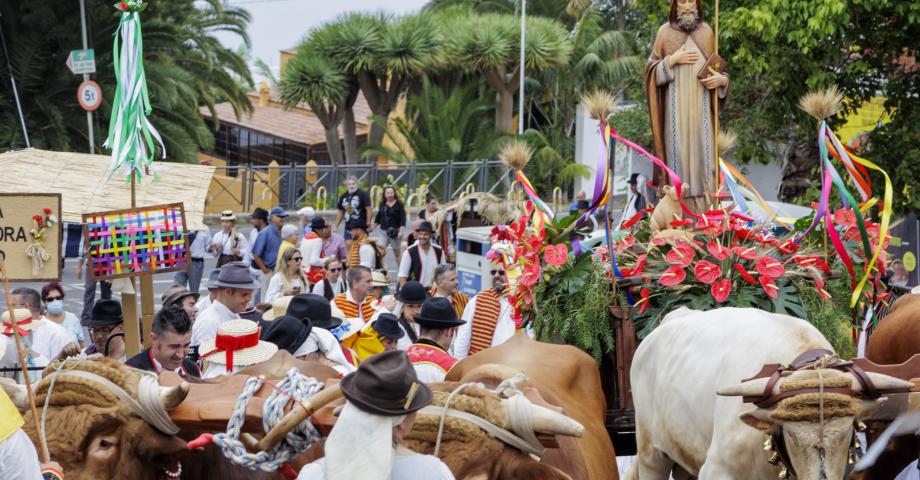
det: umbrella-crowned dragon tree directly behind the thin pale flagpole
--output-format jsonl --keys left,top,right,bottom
{"left": 449, "top": 13, "right": 572, "bottom": 134}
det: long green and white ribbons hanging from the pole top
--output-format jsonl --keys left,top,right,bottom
{"left": 102, "top": 0, "right": 166, "bottom": 182}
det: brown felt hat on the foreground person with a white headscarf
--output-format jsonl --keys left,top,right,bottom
{"left": 341, "top": 350, "right": 432, "bottom": 417}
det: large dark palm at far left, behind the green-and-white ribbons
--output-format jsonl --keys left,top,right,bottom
{"left": 0, "top": 0, "right": 252, "bottom": 162}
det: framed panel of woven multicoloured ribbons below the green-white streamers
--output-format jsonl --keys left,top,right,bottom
{"left": 83, "top": 203, "right": 189, "bottom": 280}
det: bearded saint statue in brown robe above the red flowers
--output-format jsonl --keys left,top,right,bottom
{"left": 645, "top": 0, "right": 728, "bottom": 212}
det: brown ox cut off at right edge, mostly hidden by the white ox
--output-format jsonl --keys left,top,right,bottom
{"left": 850, "top": 295, "right": 920, "bottom": 480}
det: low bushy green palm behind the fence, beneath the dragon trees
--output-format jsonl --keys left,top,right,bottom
{"left": 363, "top": 78, "right": 495, "bottom": 163}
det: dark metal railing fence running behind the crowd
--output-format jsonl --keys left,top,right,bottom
{"left": 208, "top": 160, "right": 514, "bottom": 211}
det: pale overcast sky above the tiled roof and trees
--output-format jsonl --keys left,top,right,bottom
{"left": 218, "top": 0, "right": 427, "bottom": 78}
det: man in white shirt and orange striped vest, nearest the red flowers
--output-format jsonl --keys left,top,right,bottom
{"left": 453, "top": 265, "right": 515, "bottom": 360}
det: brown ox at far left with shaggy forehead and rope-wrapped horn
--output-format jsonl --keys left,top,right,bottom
{"left": 4, "top": 351, "right": 338, "bottom": 480}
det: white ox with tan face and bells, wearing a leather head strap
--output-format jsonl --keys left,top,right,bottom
{"left": 627, "top": 308, "right": 909, "bottom": 480}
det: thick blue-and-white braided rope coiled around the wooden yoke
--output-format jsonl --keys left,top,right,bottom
{"left": 214, "top": 368, "right": 323, "bottom": 472}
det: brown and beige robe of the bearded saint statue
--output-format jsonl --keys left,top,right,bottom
{"left": 645, "top": 22, "right": 727, "bottom": 211}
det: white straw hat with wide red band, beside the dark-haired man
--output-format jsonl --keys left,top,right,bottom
{"left": 198, "top": 319, "right": 278, "bottom": 372}
